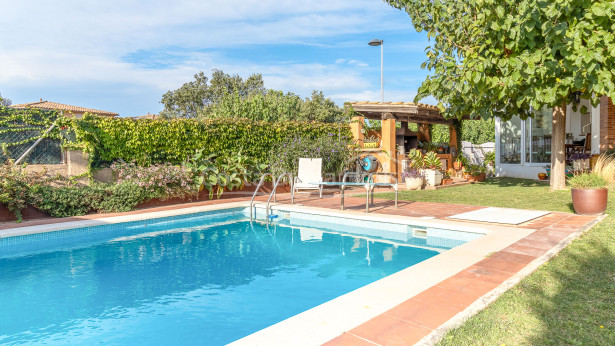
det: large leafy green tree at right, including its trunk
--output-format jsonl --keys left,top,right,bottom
{"left": 385, "top": 0, "right": 615, "bottom": 189}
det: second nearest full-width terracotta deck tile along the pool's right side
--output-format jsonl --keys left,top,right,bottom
{"left": 385, "top": 298, "right": 459, "bottom": 329}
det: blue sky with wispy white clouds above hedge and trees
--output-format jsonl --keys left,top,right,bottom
{"left": 0, "top": 0, "right": 434, "bottom": 116}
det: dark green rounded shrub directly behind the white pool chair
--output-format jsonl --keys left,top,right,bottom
{"left": 269, "top": 133, "right": 354, "bottom": 175}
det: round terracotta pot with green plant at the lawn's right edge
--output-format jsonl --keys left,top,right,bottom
{"left": 568, "top": 154, "right": 615, "bottom": 215}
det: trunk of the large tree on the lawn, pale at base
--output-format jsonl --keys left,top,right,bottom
{"left": 551, "top": 105, "right": 566, "bottom": 190}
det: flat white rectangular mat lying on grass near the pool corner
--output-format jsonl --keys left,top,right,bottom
{"left": 448, "top": 207, "right": 550, "bottom": 225}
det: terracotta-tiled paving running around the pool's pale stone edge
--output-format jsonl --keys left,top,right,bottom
{"left": 0, "top": 194, "right": 600, "bottom": 345}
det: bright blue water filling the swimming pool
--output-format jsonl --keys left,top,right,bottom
{"left": 0, "top": 210, "right": 476, "bottom": 345}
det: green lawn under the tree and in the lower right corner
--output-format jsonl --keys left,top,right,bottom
{"left": 379, "top": 178, "right": 615, "bottom": 345}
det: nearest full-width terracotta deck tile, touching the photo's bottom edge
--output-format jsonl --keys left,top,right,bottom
{"left": 348, "top": 315, "right": 432, "bottom": 346}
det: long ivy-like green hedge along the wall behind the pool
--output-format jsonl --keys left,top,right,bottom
{"left": 64, "top": 115, "right": 351, "bottom": 168}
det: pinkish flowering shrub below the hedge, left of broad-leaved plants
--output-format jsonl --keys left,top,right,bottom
{"left": 111, "top": 162, "right": 199, "bottom": 199}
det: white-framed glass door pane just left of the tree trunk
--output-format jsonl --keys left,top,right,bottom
{"left": 525, "top": 108, "right": 553, "bottom": 163}
